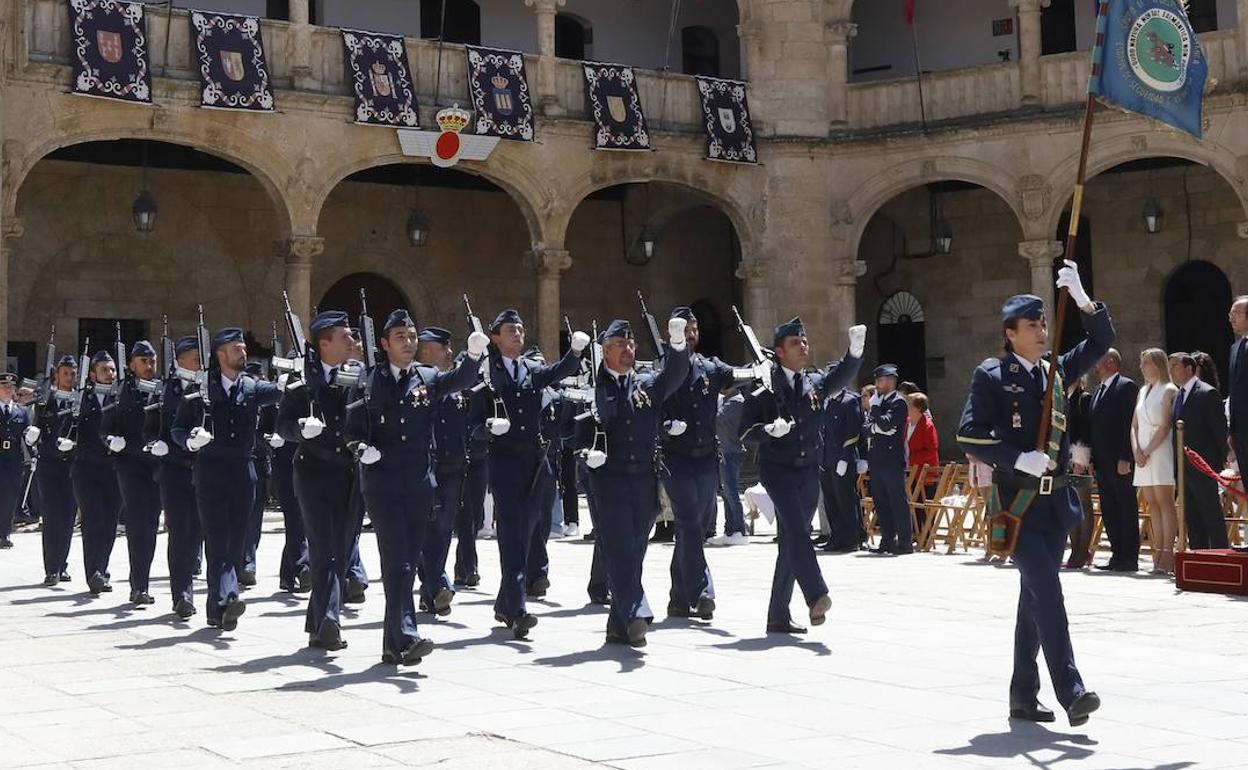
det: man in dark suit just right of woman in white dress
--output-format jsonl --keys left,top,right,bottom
{"left": 1169, "top": 353, "right": 1227, "bottom": 549}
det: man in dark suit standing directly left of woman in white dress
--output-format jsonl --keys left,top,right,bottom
{"left": 1088, "top": 348, "right": 1139, "bottom": 572}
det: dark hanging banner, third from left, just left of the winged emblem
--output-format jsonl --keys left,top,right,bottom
{"left": 342, "top": 30, "right": 421, "bottom": 129}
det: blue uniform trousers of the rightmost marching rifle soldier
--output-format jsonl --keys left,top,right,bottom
{"left": 759, "top": 463, "right": 827, "bottom": 623}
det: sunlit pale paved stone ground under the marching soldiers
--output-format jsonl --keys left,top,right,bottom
{"left": 0, "top": 511, "right": 1248, "bottom": 770}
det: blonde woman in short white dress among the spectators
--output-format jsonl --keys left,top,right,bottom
{"left": 1131, "top": 348, "right": 1178, "bottom": 575}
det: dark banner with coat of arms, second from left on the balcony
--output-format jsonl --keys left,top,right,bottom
{"left": 191, "top": 11, "right": 273, "bottom": 112}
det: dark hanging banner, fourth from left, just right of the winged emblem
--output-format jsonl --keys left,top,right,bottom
{"left": 464, "top": 45, "right": 533, "bottom": 142}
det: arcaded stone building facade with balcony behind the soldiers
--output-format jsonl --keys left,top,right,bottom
{"left": 0, "top": 0, "right": 1248, "bottom": 449}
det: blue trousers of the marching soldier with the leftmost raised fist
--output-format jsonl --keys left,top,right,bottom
{"left": 361, "top": 459, "right": 433, "bottom": 655}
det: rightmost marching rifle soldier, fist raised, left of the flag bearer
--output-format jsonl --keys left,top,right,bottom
{"left": 741, "top": 318, "right": 866, "bottom": 634}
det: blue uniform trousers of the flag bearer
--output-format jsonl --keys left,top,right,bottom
{"left": 1010, "top": 499, "right": 1083, "bottom": 708}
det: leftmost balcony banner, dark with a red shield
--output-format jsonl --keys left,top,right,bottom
{"left": 69, "top": 0, "right": 152, "bottom": 104}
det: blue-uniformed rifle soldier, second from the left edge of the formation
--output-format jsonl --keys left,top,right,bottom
{"left": 26, "top": 356, "right": 77, "bottom": 585}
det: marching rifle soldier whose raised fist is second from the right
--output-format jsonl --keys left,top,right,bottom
{"left": 585, "top": 318, "right": 700, "bottom": 648}
